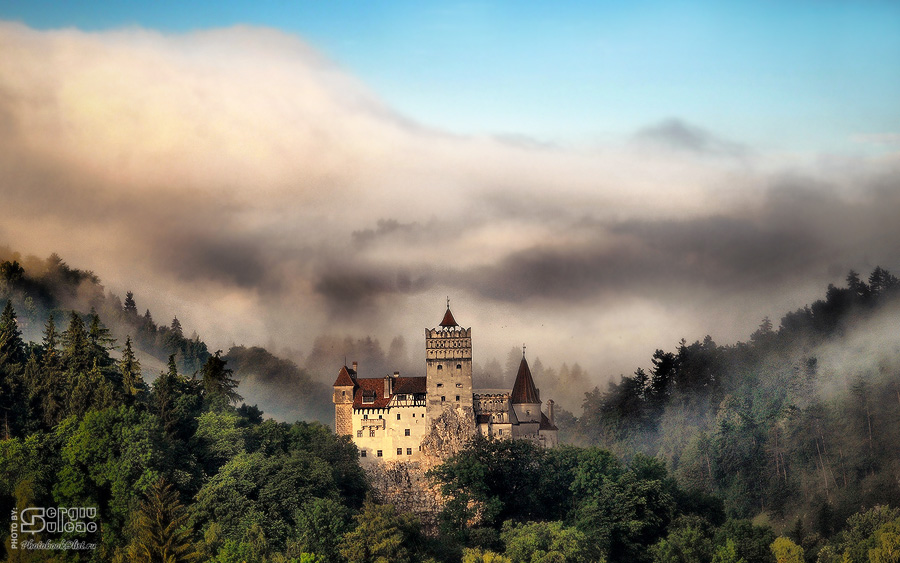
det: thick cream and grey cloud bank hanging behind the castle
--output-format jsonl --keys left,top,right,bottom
{"left": 0, "top": 24, "right": 900, "bottom": 384}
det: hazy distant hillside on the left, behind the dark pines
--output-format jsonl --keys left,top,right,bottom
{"left": 0, "top": 247, "right": 337, "bottom": 425}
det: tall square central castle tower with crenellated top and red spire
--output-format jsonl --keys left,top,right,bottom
{"left": 425, "top": 299, "right": 472, "bottom": 420}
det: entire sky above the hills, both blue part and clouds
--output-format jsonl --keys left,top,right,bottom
{"left": 0, "top": 0, "right": 900, "bottom": 398}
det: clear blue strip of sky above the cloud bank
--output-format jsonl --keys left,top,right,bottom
{"left": 0, "top": 0, "right": 900, "bottom": 154}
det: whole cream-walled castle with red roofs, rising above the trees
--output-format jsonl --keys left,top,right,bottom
{"left": 333, "top": 300, "right": 558, "bottom": 463}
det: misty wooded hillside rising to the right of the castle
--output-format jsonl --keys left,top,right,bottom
{"left": 563, "top": 268, "right": 900, "bottom": 537}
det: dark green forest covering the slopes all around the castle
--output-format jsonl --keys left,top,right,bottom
{"left": 0, "top": 251, "right": 900, "bottom": 563}
